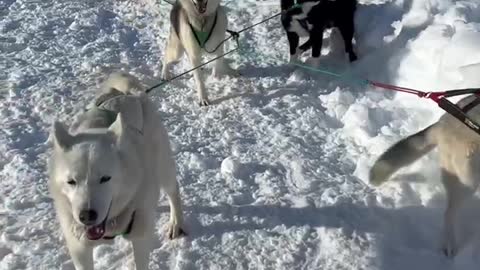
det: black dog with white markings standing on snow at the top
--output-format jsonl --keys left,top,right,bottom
{"left": 281, "top": 0, "right": 357, "bottom": 64}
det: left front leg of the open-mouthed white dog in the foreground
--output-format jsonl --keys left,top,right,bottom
{"left": 65, "top": 235, "right": 93, "bottom": 270}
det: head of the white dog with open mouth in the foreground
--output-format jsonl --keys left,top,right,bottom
{"left": 50, "top": 114, "right": 124, "bottom": 240}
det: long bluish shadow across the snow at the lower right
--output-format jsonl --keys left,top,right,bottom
{"left": 161, "top": 191, "right": 480, "bottom": 270}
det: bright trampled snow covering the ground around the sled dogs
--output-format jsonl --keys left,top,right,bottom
{"left": 0, "top": 0, "right": 480, "bottom": 270}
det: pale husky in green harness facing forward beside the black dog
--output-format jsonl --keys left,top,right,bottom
{"left": 162, "top": 0, "right": 238, "bottom": 106}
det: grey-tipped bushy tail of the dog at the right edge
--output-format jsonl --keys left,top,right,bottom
{"left": 370, "top": 124, "right": 436, "bottom": 186}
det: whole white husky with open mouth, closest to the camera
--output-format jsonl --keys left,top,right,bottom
{"left": 49, "top": 74, "right": 183, "bottom": 270}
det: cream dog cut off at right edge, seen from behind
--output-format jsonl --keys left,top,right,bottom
{"left": 370, "top": 96, "right": 480, "bottom": 256}
